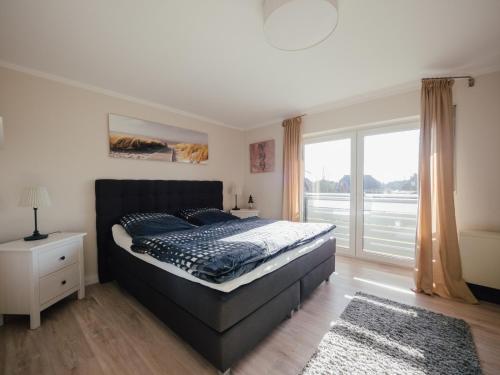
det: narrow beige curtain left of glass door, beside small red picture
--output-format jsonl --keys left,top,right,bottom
{"left": 283, "top": 117, "right": 302, "bottom": 221}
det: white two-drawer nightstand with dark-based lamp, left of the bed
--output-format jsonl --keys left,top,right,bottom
{"left": 0, "top": 233, "right": 86, "bottom": 329}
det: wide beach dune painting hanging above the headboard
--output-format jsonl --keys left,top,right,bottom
{"left": 109, "top": 113, "right": 208, "bottom": 164}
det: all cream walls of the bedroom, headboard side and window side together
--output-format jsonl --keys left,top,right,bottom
{"left": 0, "top": 68, "right": 500, "bottom": 284}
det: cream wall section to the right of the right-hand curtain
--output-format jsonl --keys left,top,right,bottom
{"left": 454, "top": 72, "right": 500, "bottom": 232}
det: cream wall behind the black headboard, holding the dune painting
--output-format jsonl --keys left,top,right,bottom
{"left": 0, "top": 68, "right": 243, "bottom": 279}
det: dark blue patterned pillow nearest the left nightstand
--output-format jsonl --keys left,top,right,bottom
{"left": 120, "top": 212, "right": 196, "bottom": 237}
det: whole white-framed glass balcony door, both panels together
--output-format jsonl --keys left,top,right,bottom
{"left": 302, "top": 123, "right": 419, "bottom": 264}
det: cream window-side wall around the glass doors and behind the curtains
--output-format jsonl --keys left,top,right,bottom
{"left": 245, "top": 72, "right": 500, "bottom": 235}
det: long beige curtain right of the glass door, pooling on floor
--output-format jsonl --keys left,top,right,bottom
{"left": 415, "top": 79, "right": 477, "bottom": 303}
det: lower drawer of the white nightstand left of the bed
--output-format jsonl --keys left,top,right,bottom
{"left": 40, "top": 264, "right": 80, "bottom": 304}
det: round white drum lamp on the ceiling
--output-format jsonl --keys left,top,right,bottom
{"left": 264, "top": 0, "right": 338, "bottom": 51}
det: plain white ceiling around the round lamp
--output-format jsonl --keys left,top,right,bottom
{"left": 0, "top": 0, "right": 500, "bottom": 128}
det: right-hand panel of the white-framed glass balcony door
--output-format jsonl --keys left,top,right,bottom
{"left": 357, "top": 124, "right": 419, "bottom": 263}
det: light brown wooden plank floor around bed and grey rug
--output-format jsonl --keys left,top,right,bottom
{"left": 0, "top": 257, "right": 500, "bottom": 375}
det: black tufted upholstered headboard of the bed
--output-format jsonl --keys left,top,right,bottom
{"left": 95, "top": 180, "right": 222, "bottom": 282}
